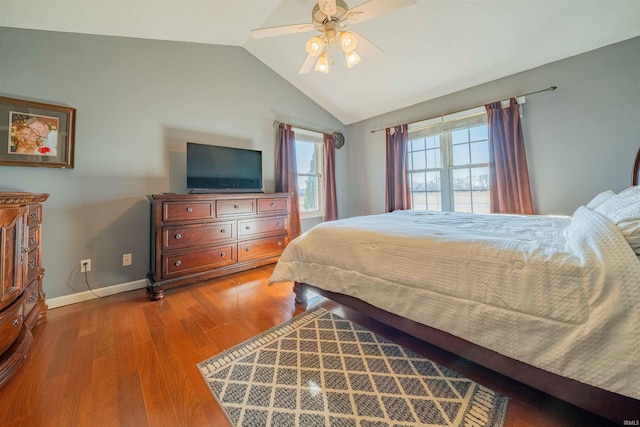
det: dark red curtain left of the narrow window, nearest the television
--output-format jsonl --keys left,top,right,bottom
{"left": 275, "top": 123, "right": 301, "bottom": 239}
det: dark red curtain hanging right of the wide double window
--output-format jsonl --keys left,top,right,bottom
{"left": 485, "top": 98, "right": 533, "bottom": 214}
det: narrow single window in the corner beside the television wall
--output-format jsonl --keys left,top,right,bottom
{"left": 293, "top": 128, "right": 324, "bottom": 218}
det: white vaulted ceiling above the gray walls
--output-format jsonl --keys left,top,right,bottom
{"left": 0, "top": 0, "right": 640, "bottom": 125}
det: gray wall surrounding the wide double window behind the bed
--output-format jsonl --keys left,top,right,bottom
{"left": 345, "top": 38, "right": 640, "bottom": 216}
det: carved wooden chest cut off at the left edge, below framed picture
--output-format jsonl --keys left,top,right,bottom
{"left": 0, "top": 192, "right": 49, "bottom": 387}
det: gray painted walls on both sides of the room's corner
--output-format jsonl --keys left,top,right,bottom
{"left": 0, "top": 27, "right": 640, "bottom": 298}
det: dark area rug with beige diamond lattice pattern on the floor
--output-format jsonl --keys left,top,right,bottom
{"left": 198, "top": 308, "right": 508, "bottom": 427}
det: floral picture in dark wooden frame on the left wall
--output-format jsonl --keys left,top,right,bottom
{"left": 0, "top": 96, "right": 76, "bottom": 169}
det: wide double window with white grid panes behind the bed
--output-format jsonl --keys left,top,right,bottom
{"left": 407, "top": 107, "right": 489, "bottom": 213}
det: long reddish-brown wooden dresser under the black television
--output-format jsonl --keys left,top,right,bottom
{"left": 147, "top": 193, "right": 291, "bottom": 300}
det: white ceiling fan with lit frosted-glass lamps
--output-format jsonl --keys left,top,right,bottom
{"left": 251, "top": 0, "right": 417, "bottom": 74}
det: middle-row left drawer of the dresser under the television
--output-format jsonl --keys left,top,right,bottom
{"left": 162, "top": 221, "right": 235, "bottom": 251}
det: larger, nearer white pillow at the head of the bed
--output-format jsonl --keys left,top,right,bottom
{"left": 593, "top": 186, "right": 640, "bottom": 255}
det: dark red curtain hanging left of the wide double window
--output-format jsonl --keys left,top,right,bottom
{"left": 385, "top": 124, "right": 411, "bottom": 212}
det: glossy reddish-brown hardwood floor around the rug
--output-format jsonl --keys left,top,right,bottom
{"left": 0, "top": 266, "right": 609, "bottom": 427}
